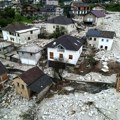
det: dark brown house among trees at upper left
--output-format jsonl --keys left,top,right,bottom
{"left": 22, "top": 4, "right": 40, "bottom": 17}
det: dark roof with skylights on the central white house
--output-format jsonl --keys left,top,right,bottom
{"left": 46, "top": 35, "right": 85, "bottom": 51}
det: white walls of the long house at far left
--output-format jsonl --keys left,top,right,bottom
{"left": 2, "top": 29, "right": 40, "bottom": 44}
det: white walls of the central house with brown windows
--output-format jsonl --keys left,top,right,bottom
{"left": 47, "top": 47, "right": 82, "bottom": 65}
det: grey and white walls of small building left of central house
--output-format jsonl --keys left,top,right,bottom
{"left": 18, "top": 52, "right": 41, "bottom": 65}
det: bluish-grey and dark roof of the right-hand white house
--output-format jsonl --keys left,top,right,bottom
{"left": 86, "top": 29, "right": 115, "bottom": 39}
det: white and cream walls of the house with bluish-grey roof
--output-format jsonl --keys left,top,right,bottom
{"left": 87, "top": 37, "right": 113, "bottom": 50}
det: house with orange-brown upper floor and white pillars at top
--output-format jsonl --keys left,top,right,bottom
{"left": 71, "top": 1, "right": 91, "bottom": 16}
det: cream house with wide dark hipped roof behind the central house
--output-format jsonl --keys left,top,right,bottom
{"left": 41, "top": 16, "right": 76, "bottom": 33}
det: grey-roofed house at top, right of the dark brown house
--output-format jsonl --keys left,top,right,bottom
{"left": 40, "top": 5, "right": 63, "bottom": 16}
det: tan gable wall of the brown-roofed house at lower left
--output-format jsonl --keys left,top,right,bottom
{"left": 13, "top": 77, "right": 31, "bottom": 99}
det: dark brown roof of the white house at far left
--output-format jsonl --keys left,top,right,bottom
{"left": 2, "top": 23, "right": 32, "bottom": 32}
